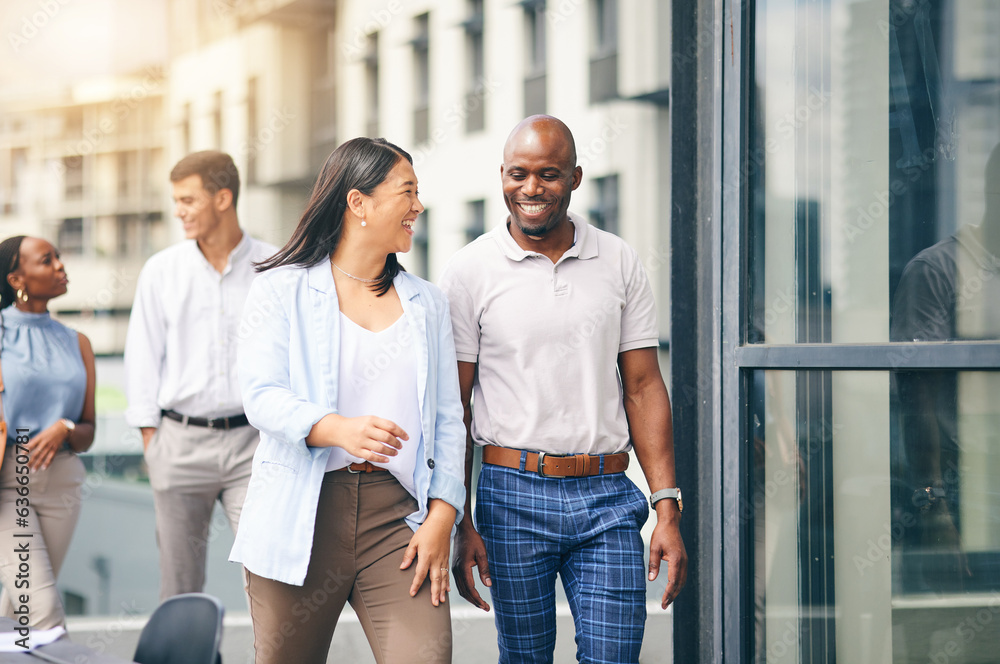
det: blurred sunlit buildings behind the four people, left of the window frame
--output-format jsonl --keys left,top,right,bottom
{"left": 0, "top": 0, "right": 670, "bottom": 661}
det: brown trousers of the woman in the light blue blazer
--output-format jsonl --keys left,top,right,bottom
{"left": 246, "top": 471, "right": 451, "bottom": 664}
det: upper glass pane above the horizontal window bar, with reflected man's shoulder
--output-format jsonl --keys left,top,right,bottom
{"left": 743, "top": 0, "right": 1000, "bottom": 343}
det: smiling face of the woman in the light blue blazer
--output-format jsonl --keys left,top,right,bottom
{"left": 365, "top": 159, "right": 424, "bottom": 253}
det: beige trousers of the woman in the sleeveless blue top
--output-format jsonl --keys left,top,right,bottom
{"left": 0, "top": 444, "right": 87, "bottom": 629}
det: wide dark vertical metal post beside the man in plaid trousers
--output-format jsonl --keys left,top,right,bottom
{"left": 670, "top": 0, "right": 724, "bottom": 664}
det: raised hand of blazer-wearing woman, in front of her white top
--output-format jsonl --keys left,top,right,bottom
{"left": 306, "top": 413, "right": 410, "bottom": 463}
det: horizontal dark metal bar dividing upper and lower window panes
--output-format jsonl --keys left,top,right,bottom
{"left": 733, "top": 341, "right": 1000, "bottom": 371}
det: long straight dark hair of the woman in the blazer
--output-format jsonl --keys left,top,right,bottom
{"left": 256, "top": 137, "right": 413, "bottom": 295}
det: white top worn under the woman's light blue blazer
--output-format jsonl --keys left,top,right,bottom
{"left": 326, "top": 312, "right": 423, "bottom": 497}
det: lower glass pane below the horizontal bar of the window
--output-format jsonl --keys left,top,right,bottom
{"left": 741, "top": 371, "right": 1000, "bottom": 664}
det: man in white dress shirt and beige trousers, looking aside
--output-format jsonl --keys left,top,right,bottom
{"left": 125, "top": 150, "right": 277, "bottom": 599}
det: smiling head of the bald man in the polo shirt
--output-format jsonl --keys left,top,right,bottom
{"left": 500, "top": 120, "right": 583, "bottom": 238}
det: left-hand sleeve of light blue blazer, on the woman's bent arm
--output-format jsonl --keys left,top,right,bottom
{"left": 237, "top": 277, "right": 333, "bottom": 455}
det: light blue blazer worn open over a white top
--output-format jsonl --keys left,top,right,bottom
{"left": 229, "top": 261, "right": 465, "bottom": 586}
